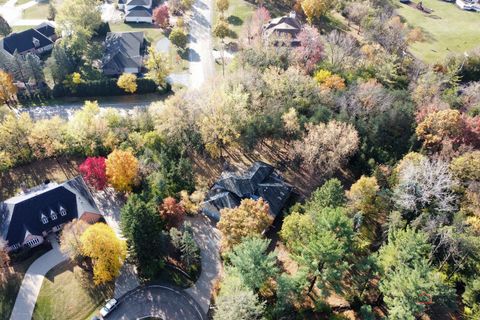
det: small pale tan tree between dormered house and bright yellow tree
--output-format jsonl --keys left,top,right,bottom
{"left": 60, "top": 219, "right": 89, "bottom": 261}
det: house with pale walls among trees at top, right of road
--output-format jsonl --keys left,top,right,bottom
{"left": 263, "top": 12, "right": 302, "bottom": 47}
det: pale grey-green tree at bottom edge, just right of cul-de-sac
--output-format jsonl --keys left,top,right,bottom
{"left": 213, "top": 289, "right": 265, "bottom": 320}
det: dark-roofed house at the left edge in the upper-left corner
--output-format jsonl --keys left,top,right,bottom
{"left": 0, "top": 22, "right": 57, "bottom": 55}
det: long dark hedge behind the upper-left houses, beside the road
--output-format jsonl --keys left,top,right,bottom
{"left": 52, "top": 78, "right": 171, "bottom": 98}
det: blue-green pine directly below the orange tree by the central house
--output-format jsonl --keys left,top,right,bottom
{"left": 227, "top": 237, "right": 279, "bottom": 291}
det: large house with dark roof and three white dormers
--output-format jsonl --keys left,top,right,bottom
{"left": 0, "top": 177, "right": 103, "bottom": 251}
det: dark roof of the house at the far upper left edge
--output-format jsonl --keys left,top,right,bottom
{"left": 2, "top": 27, "right": 55, "bottom": 54}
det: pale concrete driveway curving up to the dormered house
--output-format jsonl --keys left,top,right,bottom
{"left": 10, "top": 240, "right": 67, "bottom": 320}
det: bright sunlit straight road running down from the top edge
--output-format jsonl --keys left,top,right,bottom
{"left": 189, "top": 0, "right": 215, "bottom": 89}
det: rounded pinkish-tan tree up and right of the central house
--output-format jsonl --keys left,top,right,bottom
{"left": 295, "top": 120, "right": 359, "bottom": 175}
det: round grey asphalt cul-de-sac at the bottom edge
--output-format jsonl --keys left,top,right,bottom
{"left": 105, "top": 286, "right": 205, "bottom": 320}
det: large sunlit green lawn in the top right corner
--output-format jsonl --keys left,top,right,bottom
{"left": 398, "top": 0, "right": 480, "bottom": 63}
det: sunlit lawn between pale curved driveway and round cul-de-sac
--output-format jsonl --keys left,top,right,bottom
{"left": 32, "top": 262, "right": 113, "bottom": 320}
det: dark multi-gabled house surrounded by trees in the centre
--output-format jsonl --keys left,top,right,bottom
{"left": 202, "top": 161, "right": 293, "bottom": 222}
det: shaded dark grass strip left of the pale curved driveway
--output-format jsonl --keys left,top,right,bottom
{"left": 0, "top": 246, "right": 51, "bottom": 320}
